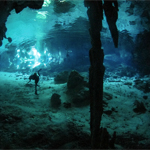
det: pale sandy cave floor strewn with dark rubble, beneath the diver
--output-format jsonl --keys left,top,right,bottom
{"left": 0, "top": 72, "right": 150, "bottom": 149}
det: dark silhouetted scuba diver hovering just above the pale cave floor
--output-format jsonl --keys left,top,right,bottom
{"left": 27, "top": 69, "right": 42, "bottom": 95}
